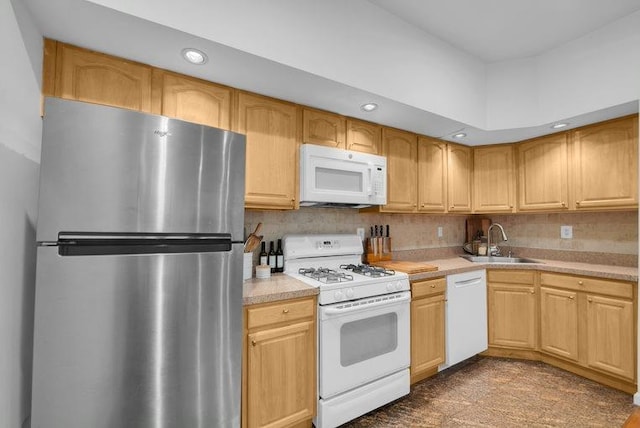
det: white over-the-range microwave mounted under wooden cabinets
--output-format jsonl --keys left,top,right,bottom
{"left": 300, "top": 144, "right": 387, "bottom": 208}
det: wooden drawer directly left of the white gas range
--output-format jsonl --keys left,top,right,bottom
{"left": 247, "top": 299, "right": 316, "bottom": 329}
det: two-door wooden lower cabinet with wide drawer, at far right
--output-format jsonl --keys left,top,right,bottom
{"left": 540, "top": 272, "right": 637, "bottom": 391}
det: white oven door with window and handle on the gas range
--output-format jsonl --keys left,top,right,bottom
{"left": 319, "top": 291, "right": 411, "bottom": 399}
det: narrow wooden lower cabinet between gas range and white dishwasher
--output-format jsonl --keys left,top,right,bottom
{"left": 410, "top": 278, "right": 447, "bottom": 383}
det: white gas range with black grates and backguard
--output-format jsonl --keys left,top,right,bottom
{"left": 283, "top": 234, "right": 411, "bottom": 428}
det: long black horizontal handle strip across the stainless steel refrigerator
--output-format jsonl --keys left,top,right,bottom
{"left": 58, "top": 232, "right": 233, "bottom": 256}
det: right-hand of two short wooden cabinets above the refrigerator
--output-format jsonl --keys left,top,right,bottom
{"left": 152, "top": 70, "right": 232, "bottom": 129}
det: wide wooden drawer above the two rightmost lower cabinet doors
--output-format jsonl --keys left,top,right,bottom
{"left": 540, "top": 272, "right": 633, "bottom": 299}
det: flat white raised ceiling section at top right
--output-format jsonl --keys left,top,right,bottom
{"left": 368, "top": 0, "right": 640, "bottom": 63}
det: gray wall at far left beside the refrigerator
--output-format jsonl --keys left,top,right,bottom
{"left": 0, "top": 0, "right": 42, "bottom": 428}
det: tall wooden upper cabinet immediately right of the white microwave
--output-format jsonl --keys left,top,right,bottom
{"left": 381, "top": 128, "right": 418, "bottom": 212}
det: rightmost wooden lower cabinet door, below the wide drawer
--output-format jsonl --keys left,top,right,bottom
{"left": 587, "top": 295, "right": 635, "bottom": 380}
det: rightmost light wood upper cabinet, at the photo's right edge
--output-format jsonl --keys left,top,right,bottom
{"left": 572, "top": 115, "right": 638, "bottom": 209}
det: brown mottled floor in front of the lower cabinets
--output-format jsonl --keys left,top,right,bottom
{"left": 342, "top": 357, "right": 634, "bottom": 428}
